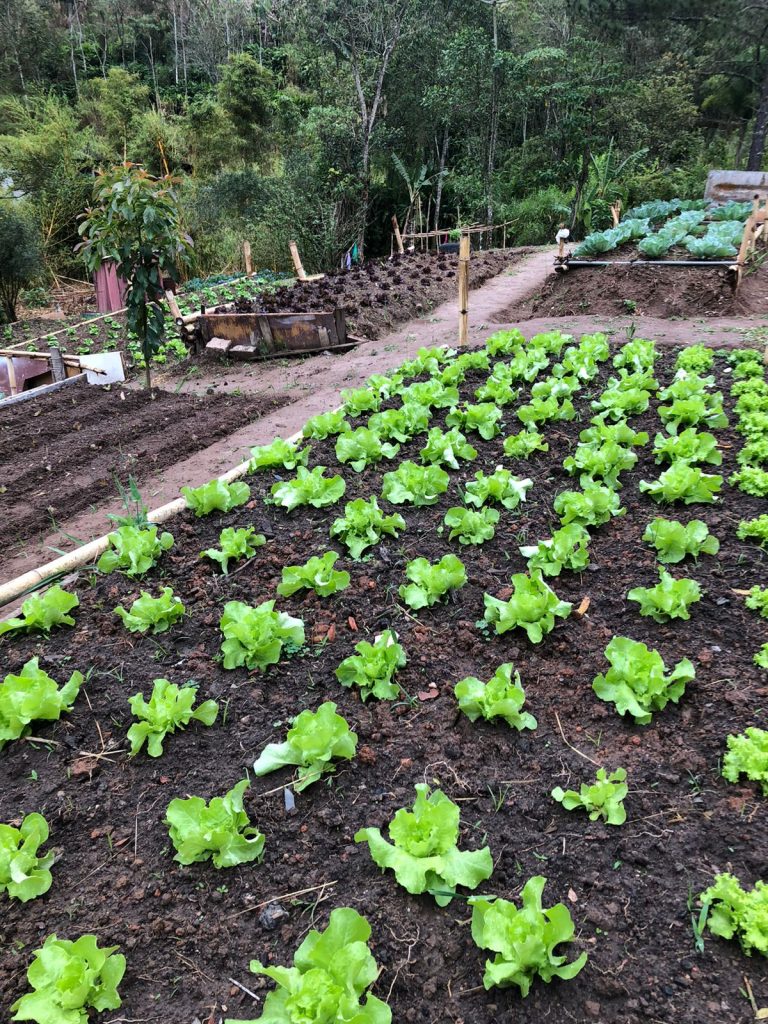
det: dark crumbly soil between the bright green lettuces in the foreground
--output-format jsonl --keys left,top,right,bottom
{"left": 0, "top": 352, "right": 768, "bottom": 1024}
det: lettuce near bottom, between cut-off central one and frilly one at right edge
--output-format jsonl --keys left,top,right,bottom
{"left": 469, "top": 874, "right": 587, "bottom": 997}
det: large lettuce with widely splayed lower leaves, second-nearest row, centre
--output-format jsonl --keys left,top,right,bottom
{"left": 354, "top": 782, "right": 494, "bottom": 906}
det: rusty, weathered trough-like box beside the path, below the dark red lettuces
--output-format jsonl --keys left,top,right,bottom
{"left": 195, "top": 308, "right": 365, "bottom": 360}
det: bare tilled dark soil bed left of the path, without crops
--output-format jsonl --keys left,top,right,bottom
{"left": 0, "top": 384, "right": 290, "bottom": 547}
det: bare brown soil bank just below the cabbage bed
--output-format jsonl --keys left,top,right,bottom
{"left": 494, "top": 262, "right": 768, "bottom": 324}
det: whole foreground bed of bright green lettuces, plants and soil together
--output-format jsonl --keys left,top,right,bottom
{"left": 0, "top": 331, "right": 768, "bottom": 1024}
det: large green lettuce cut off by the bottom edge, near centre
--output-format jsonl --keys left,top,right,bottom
{"left": 226, "top": 906, "right": 392, "bottom": 1024}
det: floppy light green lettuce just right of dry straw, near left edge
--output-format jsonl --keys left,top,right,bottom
{"left": 128, "top": 679, "right": 219, "bottom": 758}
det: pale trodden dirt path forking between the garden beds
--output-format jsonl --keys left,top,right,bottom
{"left": 0, "top": 242, "right": 768, "bottom": 580}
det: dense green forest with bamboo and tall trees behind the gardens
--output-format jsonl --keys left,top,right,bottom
{"left": 0, "top": 0, "right": 768, "bottom": 284}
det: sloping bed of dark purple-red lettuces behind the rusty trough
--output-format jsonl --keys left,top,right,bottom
{"left": 228, "top": 249, "right": 530, "bottom": 340}
